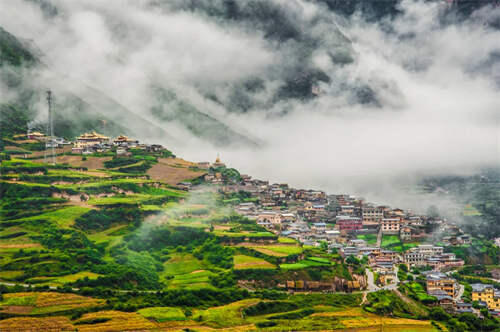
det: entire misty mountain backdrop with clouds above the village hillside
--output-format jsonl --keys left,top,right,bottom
{"left": 0, "top": 0, "right": 500, "bottom": 213}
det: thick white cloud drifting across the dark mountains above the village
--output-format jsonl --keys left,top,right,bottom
{"left": 0, "top": 0, "right": 500, "bottom": 213}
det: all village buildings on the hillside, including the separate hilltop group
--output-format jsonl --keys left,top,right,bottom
{"left": 12, "top": 131, "right": 500, "bottom": 315}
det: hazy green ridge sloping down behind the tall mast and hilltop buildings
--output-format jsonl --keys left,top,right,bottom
{"left": 0, "top": 23, "right": 251, "bottom": 145}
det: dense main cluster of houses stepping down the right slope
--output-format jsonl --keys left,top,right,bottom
{"left": 194, "top": 158, "right": 476, "bottom": 304}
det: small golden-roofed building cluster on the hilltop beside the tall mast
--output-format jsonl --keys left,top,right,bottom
{"left": 27, "top": 130, "right": 164, "bottom": 156}
